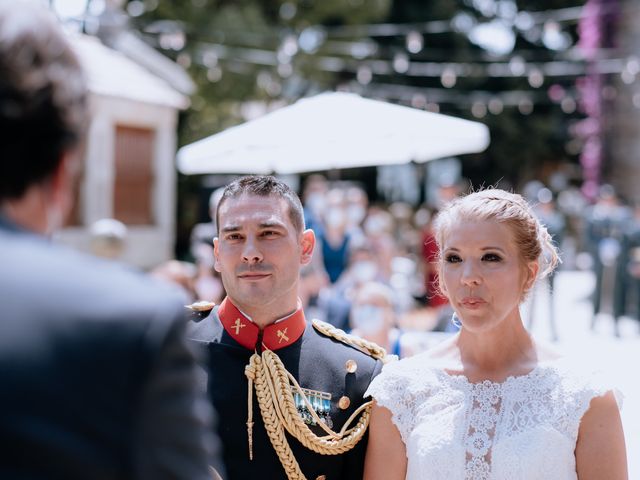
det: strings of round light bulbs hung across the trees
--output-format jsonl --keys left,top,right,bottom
{"left": 53, "top": 2, "right": 640, "bottom": 122}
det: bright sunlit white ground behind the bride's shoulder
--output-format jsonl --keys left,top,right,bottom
{"left": 523, "top": 271, "right": 640, "bottom": 480}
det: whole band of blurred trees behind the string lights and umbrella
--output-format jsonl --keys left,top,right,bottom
{"left": 135, "top": 0, "right": 584, "bottom": 187}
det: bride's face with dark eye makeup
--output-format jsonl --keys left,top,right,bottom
{"left": 441, "top": 220, "right": 537, "bottom": 331}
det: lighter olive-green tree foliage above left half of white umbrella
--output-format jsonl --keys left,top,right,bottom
{"left": 134, "top": 0, "right": 389, "bottom": 145}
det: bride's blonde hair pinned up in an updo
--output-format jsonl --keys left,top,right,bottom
{"left": 434, "top": 188, "right": 560, "bottom": 294}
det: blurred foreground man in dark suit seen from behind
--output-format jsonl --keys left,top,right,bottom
{"left": 0, "top": 0, "right": 220, "bottom": 480}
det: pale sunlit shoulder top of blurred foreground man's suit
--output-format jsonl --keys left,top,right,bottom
{"left": 0, "top": 234, "right": 184, "bottom": 336}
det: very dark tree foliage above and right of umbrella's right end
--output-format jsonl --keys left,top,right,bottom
{"left": 385, "top": 0, "right": 584, "bottom": 188}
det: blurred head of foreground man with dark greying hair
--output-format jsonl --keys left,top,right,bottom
{"left": 0, "top": 0, "right": 87, "bottom": 231}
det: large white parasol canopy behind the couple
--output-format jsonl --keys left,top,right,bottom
{"left": 178, "top": 93, "right": 489, "bottom": 174}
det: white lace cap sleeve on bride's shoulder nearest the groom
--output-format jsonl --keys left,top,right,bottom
{"left": 365, "top": 360, "right": 428, "bottom": 444}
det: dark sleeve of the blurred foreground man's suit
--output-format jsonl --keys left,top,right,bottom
{"left": 133, "top": 307, "right": 221, "bottom": 480}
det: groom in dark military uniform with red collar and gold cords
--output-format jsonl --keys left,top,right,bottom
{"left": 190, "top": 176, "right": 384, "bottom": 480}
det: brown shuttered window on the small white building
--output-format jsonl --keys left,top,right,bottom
{"left": 113, "top": 125, "right": 155, "bottom": 225}
